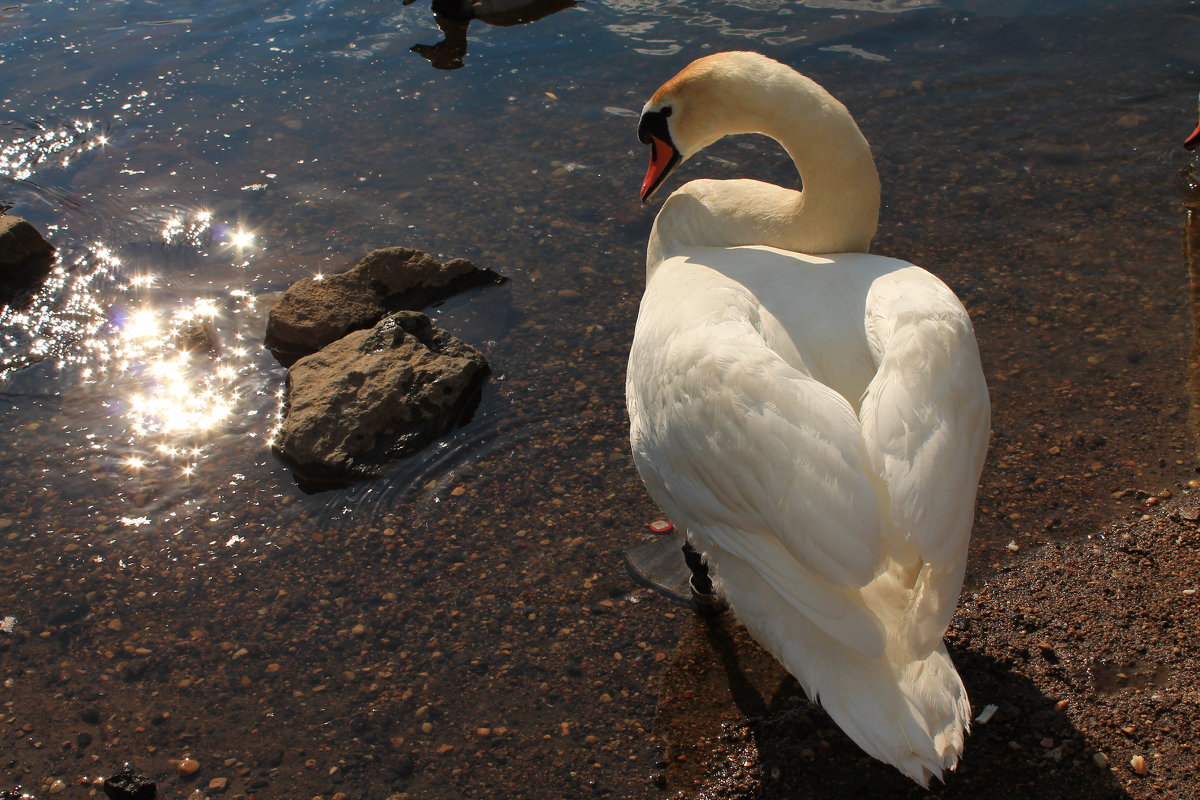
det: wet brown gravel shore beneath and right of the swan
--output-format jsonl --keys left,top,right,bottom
{"left": 655, "top": 492, "right": 1200, "bottom": 800}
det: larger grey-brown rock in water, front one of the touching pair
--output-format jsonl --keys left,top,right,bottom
{"left": 274, "top": 311, "right": 488, "bottom": 488}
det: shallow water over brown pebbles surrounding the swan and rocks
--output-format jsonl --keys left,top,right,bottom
{"left": 0, "top": 0, "right": 1200, "bottom": 798}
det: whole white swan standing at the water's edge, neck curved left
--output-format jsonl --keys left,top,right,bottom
{"left": 626, "top": 53, "right": 990, "bottom": 786}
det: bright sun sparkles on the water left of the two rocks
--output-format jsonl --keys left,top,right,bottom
{"left": 0, "top": 113, "right": 262, "bottom": 476}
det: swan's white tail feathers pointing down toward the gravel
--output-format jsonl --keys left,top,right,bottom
{"left": 714, "top": 548, "right": 971, "bottom": 788}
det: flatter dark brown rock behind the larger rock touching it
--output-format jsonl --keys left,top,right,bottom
{"left": 266, "top": 247, "right": 504, "bottom": 366}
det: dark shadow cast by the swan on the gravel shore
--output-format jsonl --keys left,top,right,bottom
{"left": 654, "top": 614, "right": 1129, "bottom": 800}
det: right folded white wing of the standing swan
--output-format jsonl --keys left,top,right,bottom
{"left": 859, "top": 267, "right": 990, "bottom": 651}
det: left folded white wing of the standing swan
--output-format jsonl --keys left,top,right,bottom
{"left": 629, "top": 312, "right": 883, "bottom": 654}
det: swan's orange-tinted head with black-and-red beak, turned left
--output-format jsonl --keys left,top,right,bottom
{"left": 637, "top": 53, "right": 798, "bottom": 203}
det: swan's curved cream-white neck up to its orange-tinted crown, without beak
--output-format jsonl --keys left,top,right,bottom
{"left": 648, "top": 53, "right": 880, "bottom": 272}
